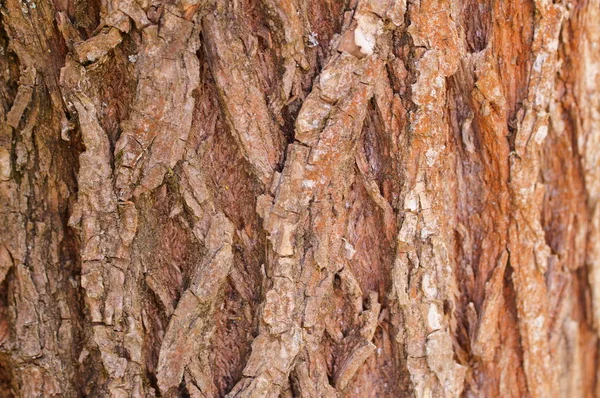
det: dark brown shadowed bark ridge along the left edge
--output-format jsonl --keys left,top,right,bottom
{"left": 0, "top": 1, "right": 86, "bottom": 388}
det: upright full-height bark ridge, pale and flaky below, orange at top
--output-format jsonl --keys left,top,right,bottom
{"left": 392, "top": 1, "right": 466, "bottom": 397}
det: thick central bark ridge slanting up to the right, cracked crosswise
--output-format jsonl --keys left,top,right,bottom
{"left": 229, "top": 2, "right": 396, "bottom": 397}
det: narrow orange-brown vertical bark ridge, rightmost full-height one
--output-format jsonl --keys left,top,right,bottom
{"left": 508, "top": 0, "right": 564, "bottom": 397}
